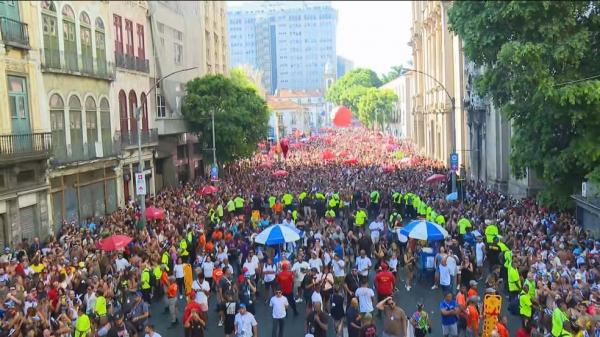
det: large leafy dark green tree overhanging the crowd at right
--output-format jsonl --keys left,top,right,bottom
{"left": 449, "top": 1, "right": 600, "bottom": 207}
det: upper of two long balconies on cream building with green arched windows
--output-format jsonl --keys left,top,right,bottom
{"left": 42, "top": 48, "right": 115, "bottom": 81}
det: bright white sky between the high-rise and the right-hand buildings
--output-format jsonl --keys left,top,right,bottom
{"left": 227, "top": 1, "right": 412, "bottom": 74}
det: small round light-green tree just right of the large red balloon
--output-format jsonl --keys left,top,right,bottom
{"left": 358, "top": 88, "right": 398, "bottom": 129}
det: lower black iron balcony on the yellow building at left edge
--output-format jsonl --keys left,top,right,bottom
{"left": 0, "top": 132, "right": 52, "bottom": 164}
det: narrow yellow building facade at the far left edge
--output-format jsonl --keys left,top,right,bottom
{"left": 0, "top": 1, "right": 51, "bottom": 246}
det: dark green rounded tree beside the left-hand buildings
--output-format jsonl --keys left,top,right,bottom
{"left": 182, "top": 75, "right": 269, "bottom": 163}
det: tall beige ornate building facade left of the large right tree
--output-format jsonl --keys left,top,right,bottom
{"left": 408, "top": 1, "right": 468, "bottom": 165}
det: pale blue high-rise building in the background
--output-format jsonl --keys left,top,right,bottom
{"left": 227, "top": 1, "right": 337, "bottom": 93}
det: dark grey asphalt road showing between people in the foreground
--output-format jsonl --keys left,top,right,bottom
{"left": 150, "top": 268, "right": 520, "bottom": 337}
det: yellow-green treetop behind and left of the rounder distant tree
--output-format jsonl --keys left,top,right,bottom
{"left": 325, "top": 68, "right": 381, "bottom": 106}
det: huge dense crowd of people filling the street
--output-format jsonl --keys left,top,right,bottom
{"left": 0, "top": 129, "right": 600, "bottom": 337}
